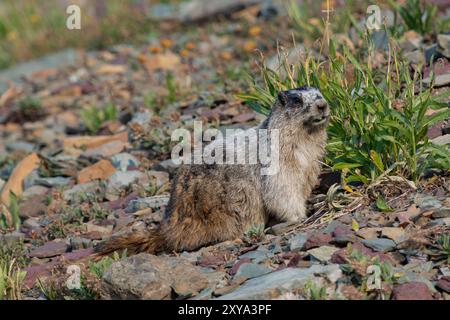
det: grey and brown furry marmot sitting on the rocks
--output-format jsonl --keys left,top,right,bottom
{"left": 96, "top": 88, "right": 328, "bottom": 254}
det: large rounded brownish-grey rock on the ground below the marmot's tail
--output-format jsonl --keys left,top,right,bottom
{"left": 102, "top": 253, "right": 209, "bottom": 300}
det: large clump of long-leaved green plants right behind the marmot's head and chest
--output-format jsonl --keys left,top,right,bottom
{"left": 238, "top": 37, "right": 450, "bottom": 184}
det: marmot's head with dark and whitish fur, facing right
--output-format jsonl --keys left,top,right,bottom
{"left": 273, "top": 87, "right": 330, "bottom": 133}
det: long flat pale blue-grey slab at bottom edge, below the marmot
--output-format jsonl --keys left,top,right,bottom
{"left": 218, "top": 264, "right": 341, "bottom": 300}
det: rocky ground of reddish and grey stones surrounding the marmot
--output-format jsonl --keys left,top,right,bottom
{"left": 0, "top": 0, "right": 450, "bottom": 300}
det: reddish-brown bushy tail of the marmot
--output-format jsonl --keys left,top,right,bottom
{"left": 94, "top": 229, "right": 165, "bottom": 256}
